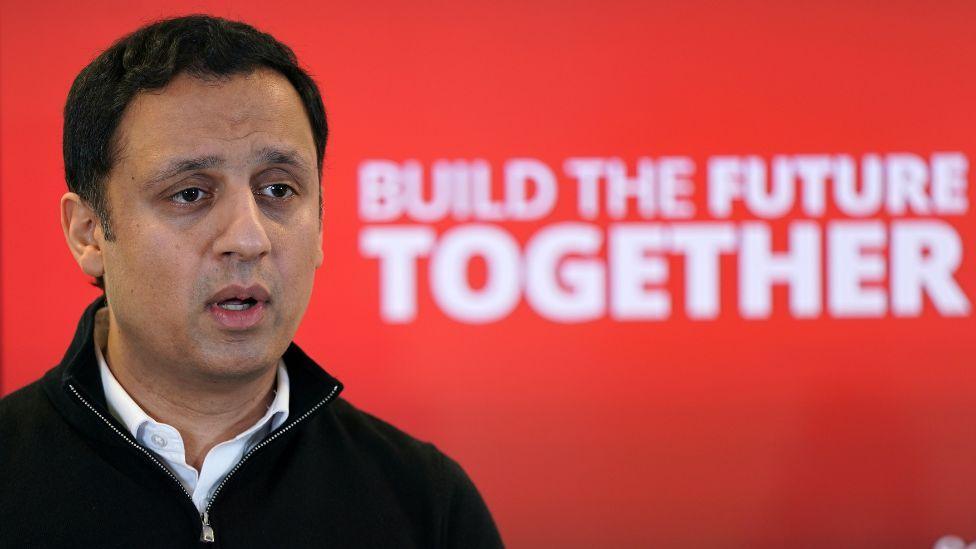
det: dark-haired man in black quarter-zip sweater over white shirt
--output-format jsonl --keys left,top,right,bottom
{"left": 0, "top": 16, "right": 501, "bottom": 547}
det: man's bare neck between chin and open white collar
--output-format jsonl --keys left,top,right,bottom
{"left": 99, "top": 310, "right": 277, "bottom": 470}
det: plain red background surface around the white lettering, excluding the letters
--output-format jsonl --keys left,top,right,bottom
{"left": 0, "top": 0, "right": 976, "bottom": 547}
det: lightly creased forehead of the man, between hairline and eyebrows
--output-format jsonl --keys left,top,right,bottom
{"left": 116, "top": 69, "right": 315, "bottom": 177}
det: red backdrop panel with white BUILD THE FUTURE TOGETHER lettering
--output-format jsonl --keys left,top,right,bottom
{"left": 0, "top": 0, "right": 976, "bottom": 547}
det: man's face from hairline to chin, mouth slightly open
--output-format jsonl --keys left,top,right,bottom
{"left": 96, "top": 69, "right": 322, "bottom": 378}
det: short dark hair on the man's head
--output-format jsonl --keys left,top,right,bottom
{"left": 63, "top": 15, "right": 328, "bottom": 286}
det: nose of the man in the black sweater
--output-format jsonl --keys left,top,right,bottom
{"left": 214, "top": 185, "right": 271, "bottom": 262}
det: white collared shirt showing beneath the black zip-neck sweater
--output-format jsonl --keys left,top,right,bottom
{"left": 95, "top": 312, "right": 289, "bottom": 514}
